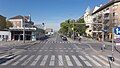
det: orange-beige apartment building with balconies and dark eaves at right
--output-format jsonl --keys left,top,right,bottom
{"left": 92, "top": 0, "right": 120, "bottom": 41}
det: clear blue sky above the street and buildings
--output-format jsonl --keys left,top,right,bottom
{"left": 0, "top": 0, "right": 110, "bottom": 30}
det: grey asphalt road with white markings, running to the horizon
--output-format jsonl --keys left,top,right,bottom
{"left": 0, "top": 34, "right": 120, "bottom": 68}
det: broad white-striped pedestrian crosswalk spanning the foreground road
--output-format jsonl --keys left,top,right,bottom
{"left": 0, "top": 55, "right": 120, "bottom": 67}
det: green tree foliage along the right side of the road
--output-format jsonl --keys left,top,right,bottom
{"left": 59, "top": 18, "right": 86, "bottom": 34}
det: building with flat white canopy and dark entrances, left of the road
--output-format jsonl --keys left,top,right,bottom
{"left": 8, "top": 15, "right": 36, "bottom": 40}
